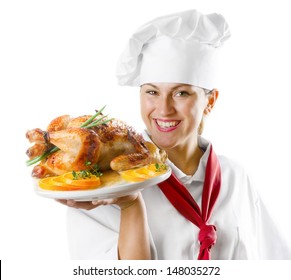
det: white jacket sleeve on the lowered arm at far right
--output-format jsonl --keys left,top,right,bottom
{"left": 233, "top": 170, "right": 291, "bottom": 260}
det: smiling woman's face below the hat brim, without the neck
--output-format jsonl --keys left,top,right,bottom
{"left": 140, "top": 83, "right": 208, "bottom": 150}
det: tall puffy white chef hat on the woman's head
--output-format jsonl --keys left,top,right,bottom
{"left": 116, "top": 10, "right": 230, "bottom": 89}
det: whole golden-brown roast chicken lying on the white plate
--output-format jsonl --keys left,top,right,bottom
{"left": 26, "top": 111, "right": 167, "bottom": 178}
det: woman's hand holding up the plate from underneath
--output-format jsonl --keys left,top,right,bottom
{"left": 56, "top": 193, "right": 138, "bottom": 210}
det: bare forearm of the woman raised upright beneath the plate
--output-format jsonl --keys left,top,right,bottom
{"left": 118, "top": 194, "right": 151, "bottom": 260}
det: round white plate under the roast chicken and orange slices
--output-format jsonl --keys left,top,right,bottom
{"left": 34, "top": 167, "right": 172, "bottom": 201}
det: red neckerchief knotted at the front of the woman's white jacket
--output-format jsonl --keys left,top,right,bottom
{"left": 158, "top": 146, "right": 221, "bottom": 260}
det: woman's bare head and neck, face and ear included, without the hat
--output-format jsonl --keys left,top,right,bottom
{"left": 140, "top": 83, "right": 218, "bottom": 174}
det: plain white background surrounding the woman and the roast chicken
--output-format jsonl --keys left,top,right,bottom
{"left": 0, "top": 0, "right": 291, "bottom": 276}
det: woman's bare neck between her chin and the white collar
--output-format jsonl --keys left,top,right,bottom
{"left": 166, "top": 139, "right": 203, "bottom": 175}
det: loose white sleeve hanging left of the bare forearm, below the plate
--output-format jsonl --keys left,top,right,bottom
{"left": 67, "top": 206, "right": 120, "bottom": 260}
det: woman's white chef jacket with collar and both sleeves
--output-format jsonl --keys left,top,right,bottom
{"left": 67, "top": 135, "right": 291, "bottom": 260}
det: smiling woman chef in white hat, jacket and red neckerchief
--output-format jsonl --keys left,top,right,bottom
{"left": 60, "top": 10, "right": 291, "bottom": 260}
